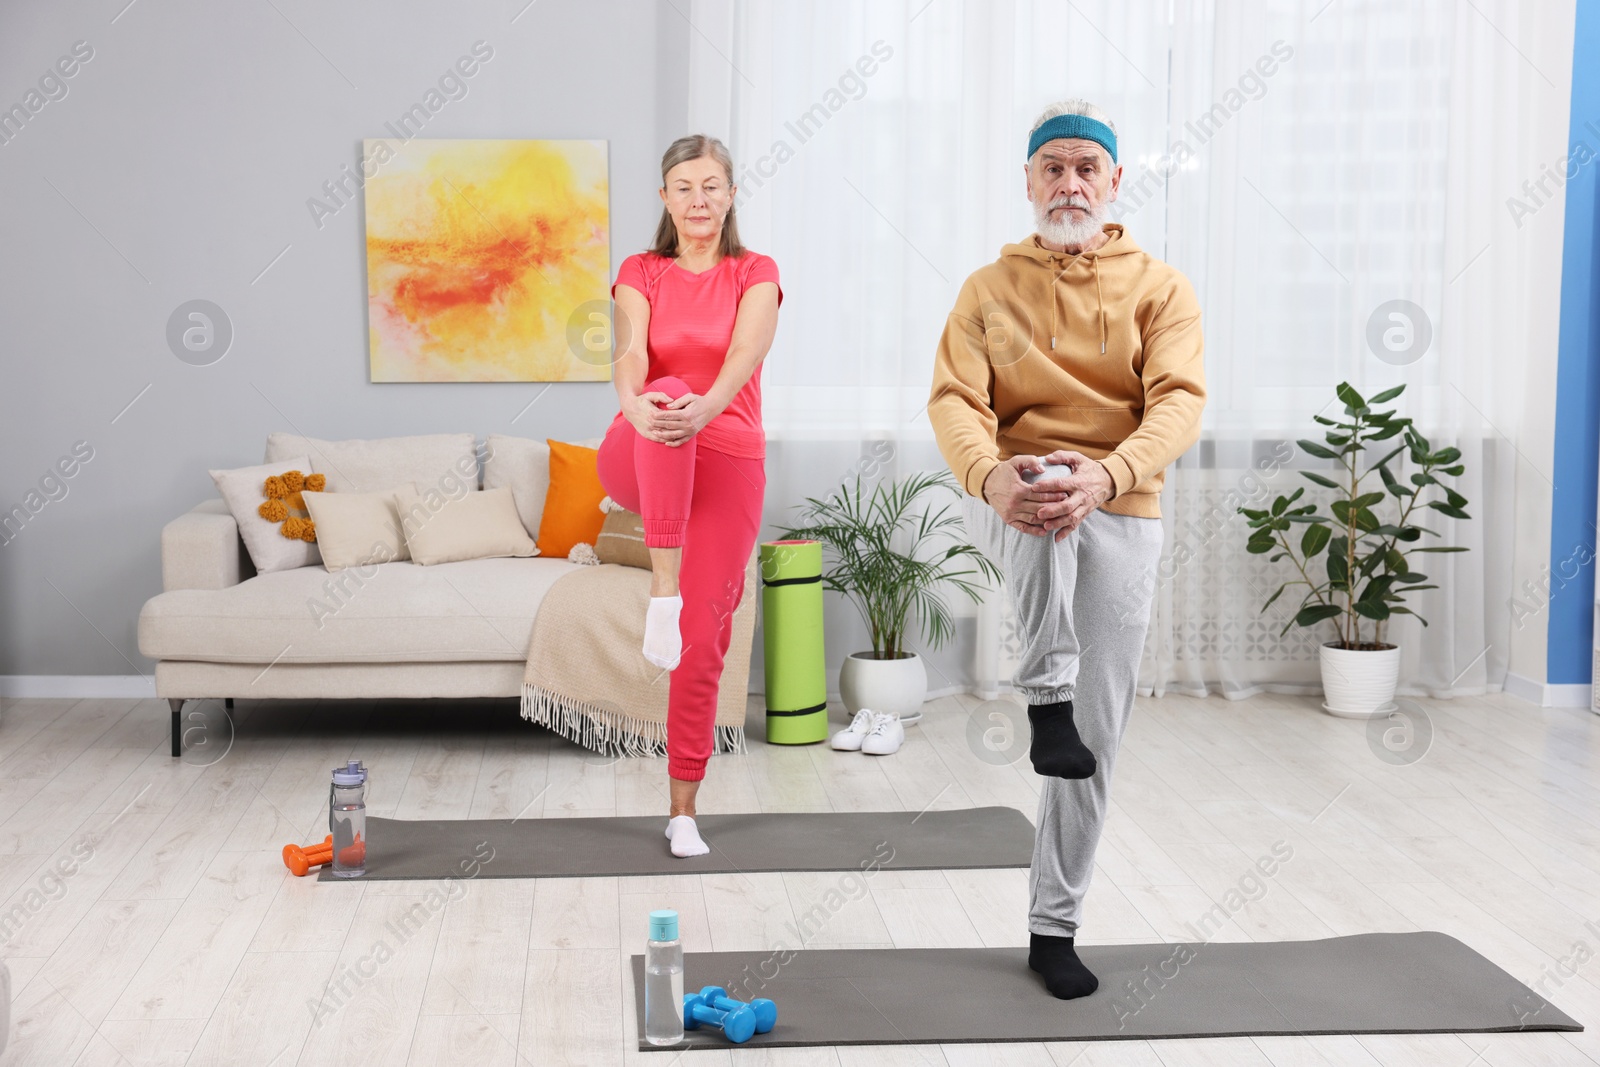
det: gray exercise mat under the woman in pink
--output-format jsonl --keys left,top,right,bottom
{"left": 317, "top": 806, "right": 1034, "bottom": 881}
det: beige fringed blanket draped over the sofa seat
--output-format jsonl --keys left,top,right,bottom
{"left": 522, "top": 549, "right": 762, "bottom": 757}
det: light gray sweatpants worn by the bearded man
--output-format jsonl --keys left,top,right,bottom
{"left": 963, "top": 494, "right": 1162, "bottom": 937}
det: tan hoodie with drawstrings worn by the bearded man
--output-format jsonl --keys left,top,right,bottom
{"left": 928, "top": 222, "right": 1205, "bottom": 518}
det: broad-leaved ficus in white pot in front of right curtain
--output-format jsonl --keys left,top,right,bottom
{"left": 1238, "top": 382, "right": 1470, "bottom": 718}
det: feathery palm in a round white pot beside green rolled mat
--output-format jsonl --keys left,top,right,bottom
{"left": 781, "top": 470, "right": 1000, "bottom": 725}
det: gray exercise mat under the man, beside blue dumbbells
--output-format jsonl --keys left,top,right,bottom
{"left": 634, "top": 931, "right": 1584, "bottom": 1051}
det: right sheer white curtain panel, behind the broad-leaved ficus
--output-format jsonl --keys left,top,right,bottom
{"left": 1125, "top": 0, "right": 1571, "bottom": 696}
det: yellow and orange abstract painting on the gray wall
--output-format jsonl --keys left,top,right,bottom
{"left": 362, "top": 139, "right": 611, "bottom": 382}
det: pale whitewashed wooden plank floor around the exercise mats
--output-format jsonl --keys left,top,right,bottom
{"left": 0, "top": 696, "right": 1600, "bottom": 1067}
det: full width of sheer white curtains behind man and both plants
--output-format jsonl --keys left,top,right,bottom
{"left": 680, "top": 0, "right": 1570, "bottom": 710}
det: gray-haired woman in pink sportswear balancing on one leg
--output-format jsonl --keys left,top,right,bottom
{"left": 598, "top": 136, "right": 782, "bottom": 856}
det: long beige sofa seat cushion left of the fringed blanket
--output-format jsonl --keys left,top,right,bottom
{"left": 139, "top": 557, "right": 576, "bottom": 662}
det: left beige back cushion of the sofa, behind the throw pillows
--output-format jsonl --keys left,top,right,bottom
{"left": 267, "top": 432, "right": 478, "bottom": 496}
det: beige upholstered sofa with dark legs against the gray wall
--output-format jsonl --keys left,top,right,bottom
{"left": 138, "top": 434, "right": 757, "bottom": 757}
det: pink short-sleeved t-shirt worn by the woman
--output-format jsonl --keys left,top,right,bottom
{"left": 611, "top": 251, "right": 784, "bottom": 459}
